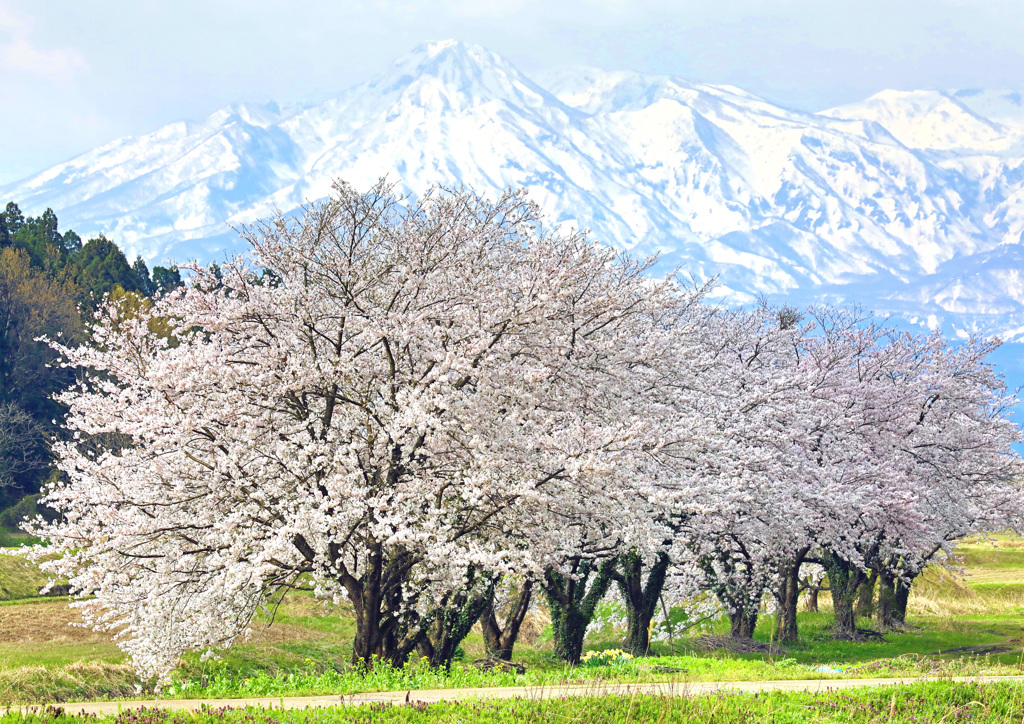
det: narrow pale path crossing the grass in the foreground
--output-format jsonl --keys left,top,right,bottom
{"left": 29, "top": 676, "right": 1024, "bottom": 716}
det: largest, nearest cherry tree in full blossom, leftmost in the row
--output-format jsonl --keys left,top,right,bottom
{"left": 28, "top": 183, "right": 685, "bottom": 674}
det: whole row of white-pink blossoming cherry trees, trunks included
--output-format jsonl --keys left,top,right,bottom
{"left": 25, "top": 184, "right": 1024, "bottom": 674}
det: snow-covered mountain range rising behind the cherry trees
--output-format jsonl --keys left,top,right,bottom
{"left": 0, "top": 41, "right": 1024, "bottom": 340}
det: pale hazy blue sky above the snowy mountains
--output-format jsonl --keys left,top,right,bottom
{"left": 6, "top": 0, "right": 1024, "bottom": 183}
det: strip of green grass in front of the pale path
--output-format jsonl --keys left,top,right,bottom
{"left": 9, "top": 682, "right": 1024, "bottom": 724}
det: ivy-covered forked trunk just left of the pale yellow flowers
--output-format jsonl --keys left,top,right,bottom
{"left": 544, "top": 560, "right": 614, "bottom": 664}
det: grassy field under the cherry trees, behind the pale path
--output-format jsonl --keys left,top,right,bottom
{"left": 0, "top": 541, "right": 1024, "bottom": 704}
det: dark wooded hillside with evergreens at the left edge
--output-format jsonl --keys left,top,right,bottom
{"left": 0, "top": 202, "right": 181, "bottom": 516}
